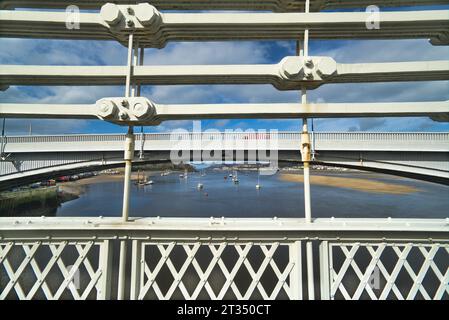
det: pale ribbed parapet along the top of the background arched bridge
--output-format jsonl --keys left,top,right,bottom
{"left": 0, "top": 132, "right": 449, "bottom": 153}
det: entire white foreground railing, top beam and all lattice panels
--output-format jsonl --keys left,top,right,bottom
{"left": 0, "top": 218, "right": 449, "bottom": 299}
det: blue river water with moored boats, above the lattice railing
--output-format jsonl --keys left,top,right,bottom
{"left": 56, "top": 170, "right": 449, "bottom": 218}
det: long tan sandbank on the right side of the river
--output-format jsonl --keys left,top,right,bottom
{"left": 280, "top": 173, "right": 421, "bottom": 194}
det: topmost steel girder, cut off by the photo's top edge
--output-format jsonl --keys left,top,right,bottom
{"left": 0, "top": 0, "right": 448, "bottom": 12}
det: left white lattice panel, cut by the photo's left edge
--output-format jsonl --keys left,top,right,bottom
{"left": 0, "top": 240, "right": 110, "bottom": 300}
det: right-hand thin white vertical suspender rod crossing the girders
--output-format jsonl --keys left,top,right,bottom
{"left": 297, "top": 0, "right": 315, "bottom": 300}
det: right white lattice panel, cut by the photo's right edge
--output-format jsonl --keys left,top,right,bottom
{"left": 321, "top": 242, "right": 449, "bottom": 300}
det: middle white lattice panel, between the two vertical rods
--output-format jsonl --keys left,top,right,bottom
{"left": 133, "top": 241, "right": 300, "bottom": 300}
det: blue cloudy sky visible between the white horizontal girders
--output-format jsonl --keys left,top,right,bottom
{"left": 0, "top": 6, "right": 449, "bottom": 134}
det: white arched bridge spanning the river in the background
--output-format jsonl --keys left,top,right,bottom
{"left": 0, "top": 132, "right": 449, "bottom": 188}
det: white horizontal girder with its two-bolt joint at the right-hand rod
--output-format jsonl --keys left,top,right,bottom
{"left": 0, "top": 57, "right": 449, "bottom": 90}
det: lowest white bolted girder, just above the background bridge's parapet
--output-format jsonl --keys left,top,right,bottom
{"left": 0, "top": 97, "right": 449, "bottom": 125}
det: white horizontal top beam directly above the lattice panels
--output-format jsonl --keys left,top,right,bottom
{"left": 0, "top": 217, "right": 449, "bottom": 236}
